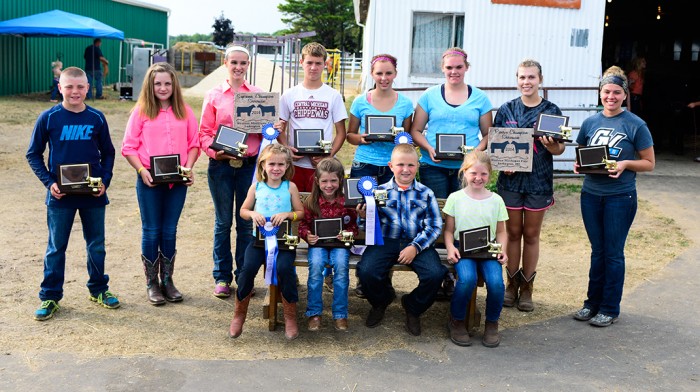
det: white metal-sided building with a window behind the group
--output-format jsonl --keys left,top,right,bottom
{"left": 354, "top": 0, "right": 605, "bottom": 168}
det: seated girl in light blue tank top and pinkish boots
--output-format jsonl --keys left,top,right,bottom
{"left": 229, "top": 144, "right": 304, "bottom": 340}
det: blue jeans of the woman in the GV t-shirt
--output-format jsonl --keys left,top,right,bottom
{"left": 581, "top": 191, "right": 637, "bottom": 317}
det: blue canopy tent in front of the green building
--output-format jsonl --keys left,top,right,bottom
{"left": 0, "top": 10, "right": 124, "bottom": 95}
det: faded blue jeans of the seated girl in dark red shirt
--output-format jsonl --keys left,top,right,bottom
{"left": 306, "top": 246, "right": 350, "bottom": 319}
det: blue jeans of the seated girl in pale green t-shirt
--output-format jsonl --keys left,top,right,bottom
{"left": 450, "top": 259, "right": 506, "bottom": 321}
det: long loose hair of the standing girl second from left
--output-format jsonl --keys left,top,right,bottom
{"left": 134, "top": 63, "right": 187, "bottom": 120}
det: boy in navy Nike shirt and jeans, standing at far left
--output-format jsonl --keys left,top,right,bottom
{"left": 27, "top": 67, "right": 119, "bottom": 321}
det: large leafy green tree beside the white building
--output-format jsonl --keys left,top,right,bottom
{"left": 277, "top": 0, "right": 361, "bottom": 53}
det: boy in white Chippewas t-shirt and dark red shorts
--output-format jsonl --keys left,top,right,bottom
{"left": 279, "top": 42, "right": 348, "bottom": 192}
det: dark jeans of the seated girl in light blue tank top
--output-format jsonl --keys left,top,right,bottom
{"left": 236, "top": 243, "right": 299, "bottom": 303}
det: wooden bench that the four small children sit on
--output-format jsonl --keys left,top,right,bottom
{"left": 263, "top": 193, "right": 484, "bottom": 331}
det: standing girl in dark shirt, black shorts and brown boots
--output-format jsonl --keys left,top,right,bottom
{"left": 494, "top": 59, "right": 565, "bottom": 312}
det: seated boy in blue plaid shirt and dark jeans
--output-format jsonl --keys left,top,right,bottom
{"left": 357, "top": 144, "right": 447, "bottom": 336}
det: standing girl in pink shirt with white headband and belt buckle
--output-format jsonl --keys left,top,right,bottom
{"left": 199, "top": 45, "right": 262, "bottom": 298}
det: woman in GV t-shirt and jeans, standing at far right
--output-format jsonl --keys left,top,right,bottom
{"left": 574, "top": 66, "right": 656, "bottom": 327}
